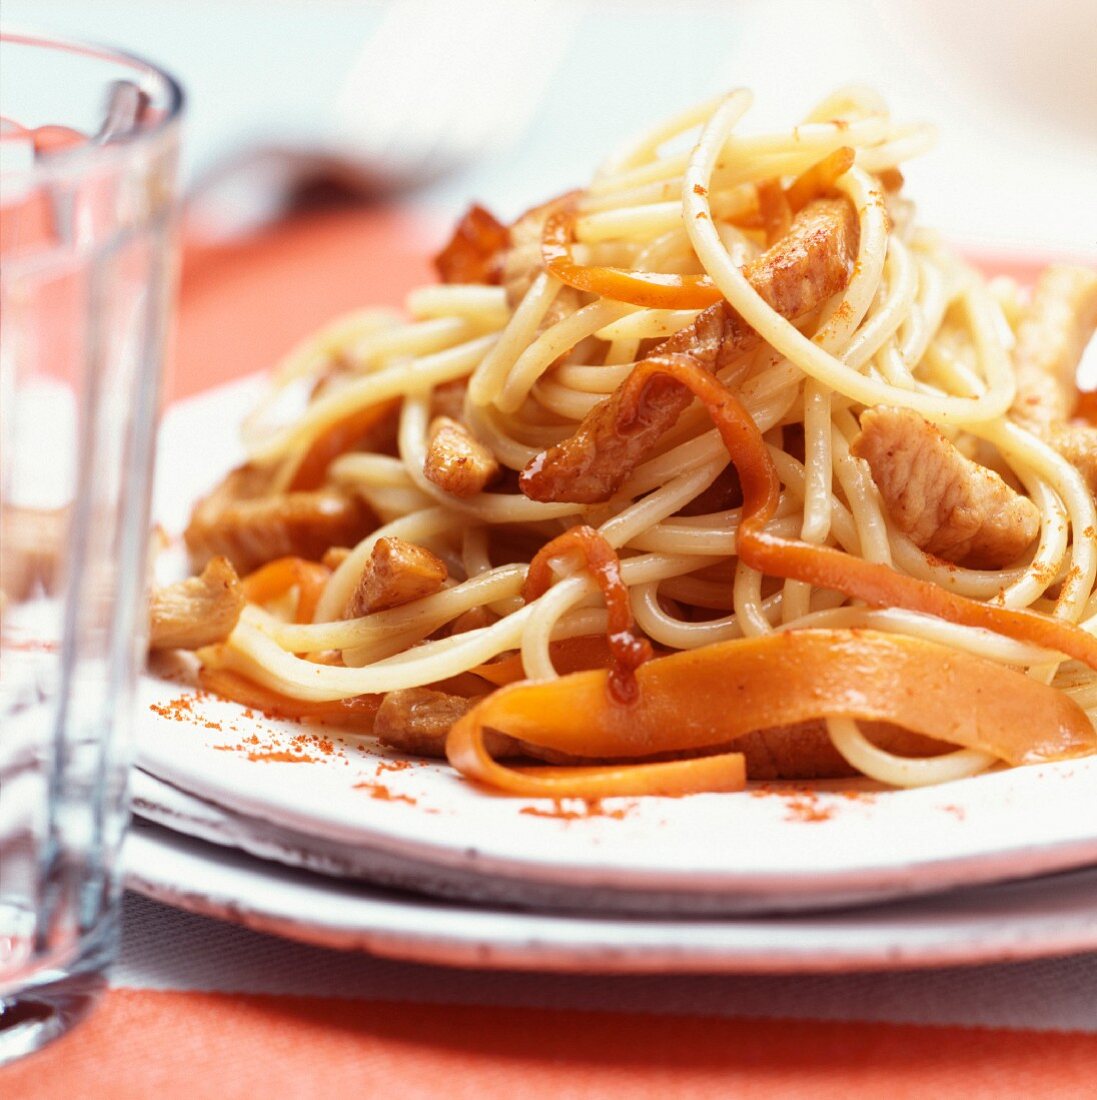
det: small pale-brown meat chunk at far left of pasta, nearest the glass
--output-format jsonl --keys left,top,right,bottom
{"left": 149, "top": 558, "right": 245, "bottom": 649}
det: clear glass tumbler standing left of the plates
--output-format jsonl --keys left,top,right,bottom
{"left": 0, "top": 31, "right": 183, "bottom": 1065}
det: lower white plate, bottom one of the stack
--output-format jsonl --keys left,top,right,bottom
{"left": 123, "top": 823, "right": 1097, "bottom": 974}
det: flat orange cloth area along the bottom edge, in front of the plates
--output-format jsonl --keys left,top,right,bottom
{"left": 10, "top": 990, "right": 1097, "bottom": 1100}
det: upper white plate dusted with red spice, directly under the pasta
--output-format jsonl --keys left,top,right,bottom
{"left": 138, "top": 382, "right": 1097, "bottom": 912}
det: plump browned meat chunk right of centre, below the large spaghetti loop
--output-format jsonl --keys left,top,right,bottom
{"left": 851, "top": 406, "right": 1040, "bottom": 569}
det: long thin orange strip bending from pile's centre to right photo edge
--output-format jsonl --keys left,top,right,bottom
{"left": 622, "top": 358, "right": 1097, "bottom": 669}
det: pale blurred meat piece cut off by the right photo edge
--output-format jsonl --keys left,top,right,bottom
{"left": 1010, "top": 265, "right": 1097, "bottom": 494}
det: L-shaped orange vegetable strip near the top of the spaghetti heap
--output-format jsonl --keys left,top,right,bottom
{"left": 541, "top": 198, "right": 724, "bottom": 309}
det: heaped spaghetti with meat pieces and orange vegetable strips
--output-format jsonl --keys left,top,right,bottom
{"left": 152, "top": 88, "right": 1097, "bottom": 798}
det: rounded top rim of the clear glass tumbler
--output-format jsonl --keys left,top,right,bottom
{"left": 0, "top": 23, "right": 187, "bottom": 184}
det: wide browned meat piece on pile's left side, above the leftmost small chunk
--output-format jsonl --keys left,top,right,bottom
{"left": 184, "top": 465, "right": 376, "bottom": 574}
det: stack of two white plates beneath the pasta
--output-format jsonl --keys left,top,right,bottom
{"left": 127, "top": 380, "right": 1097, "bottom": 970}
